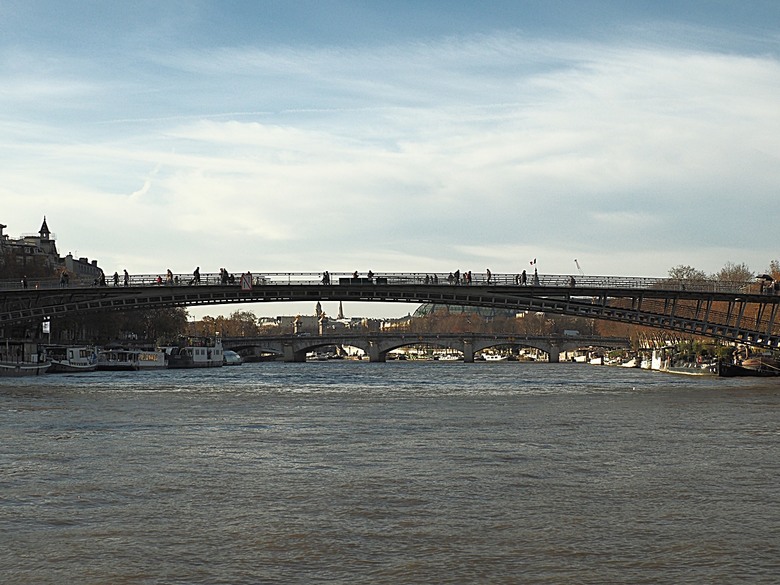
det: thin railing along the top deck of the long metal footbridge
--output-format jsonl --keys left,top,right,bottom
{"left": 0, "top": 271, "right": 775, "bottom": 294}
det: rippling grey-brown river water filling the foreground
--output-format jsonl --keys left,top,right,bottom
{"left": 0, "top": 362, "right": 780, "bottom": 584}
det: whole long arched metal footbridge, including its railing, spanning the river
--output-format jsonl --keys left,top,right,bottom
{"left": 0, "top": 273, "right": 780, "bottom": 348}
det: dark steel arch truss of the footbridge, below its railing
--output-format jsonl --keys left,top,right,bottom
{"left": 0, "top": 275, "right": 780, "bottom": 348}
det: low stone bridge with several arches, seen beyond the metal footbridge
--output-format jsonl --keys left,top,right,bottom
{"left": 222, "top": 333, "right": 631, "bottom": 363}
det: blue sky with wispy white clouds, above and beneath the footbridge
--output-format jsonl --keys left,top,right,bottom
{"left": 0, "top": 0, "right": 780, "bottom": 317}
